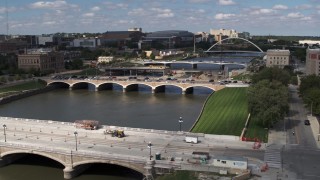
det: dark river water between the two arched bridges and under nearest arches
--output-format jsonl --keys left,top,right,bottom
{"left": 0, "top": 89, "right": 211, "bottom": 180}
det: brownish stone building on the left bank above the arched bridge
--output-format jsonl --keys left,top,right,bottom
{"left": 18, "top": 49, "right": 64, "bottom": 72}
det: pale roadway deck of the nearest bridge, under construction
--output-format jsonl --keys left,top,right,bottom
{"left": 0, "top": 117, "right": 264, "bottom": 169}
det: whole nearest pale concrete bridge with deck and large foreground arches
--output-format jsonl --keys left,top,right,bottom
{"left": 0, "top": 117, "right": 261, "bottom": 179}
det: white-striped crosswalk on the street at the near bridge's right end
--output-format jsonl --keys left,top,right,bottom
{"left": 264, "top": 144, "right": 282, "bottom": 169}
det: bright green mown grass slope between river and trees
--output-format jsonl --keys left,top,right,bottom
{"left": 192, "top": 88, "right": 248, "bottom": 136}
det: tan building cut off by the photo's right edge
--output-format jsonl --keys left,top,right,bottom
{"left": 306, "top": 49, "right": 320, "bottom": 76}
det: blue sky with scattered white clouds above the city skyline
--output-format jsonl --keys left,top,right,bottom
{"left": 0, "top": 0, "right": 320, "bottom": 36}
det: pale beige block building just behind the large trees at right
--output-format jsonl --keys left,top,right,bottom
{"left": 266, "top": 49, "right": 290, "bottom": 68}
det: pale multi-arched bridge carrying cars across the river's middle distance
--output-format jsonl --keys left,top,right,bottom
{"left": 43, "top": 79, "right": 230, "bottom": 94}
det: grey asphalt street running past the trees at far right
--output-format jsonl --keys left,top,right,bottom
{"left": 282, "top": 86, "right": 320, "bottom": 180}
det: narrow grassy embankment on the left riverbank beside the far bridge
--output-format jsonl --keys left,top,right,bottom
{"left": 0, "top": 81, "right": 46, "bottom": 97}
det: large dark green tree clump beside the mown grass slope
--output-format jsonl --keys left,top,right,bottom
{"left": 248, "top": 67, "right": 291, "bottom": 128}
